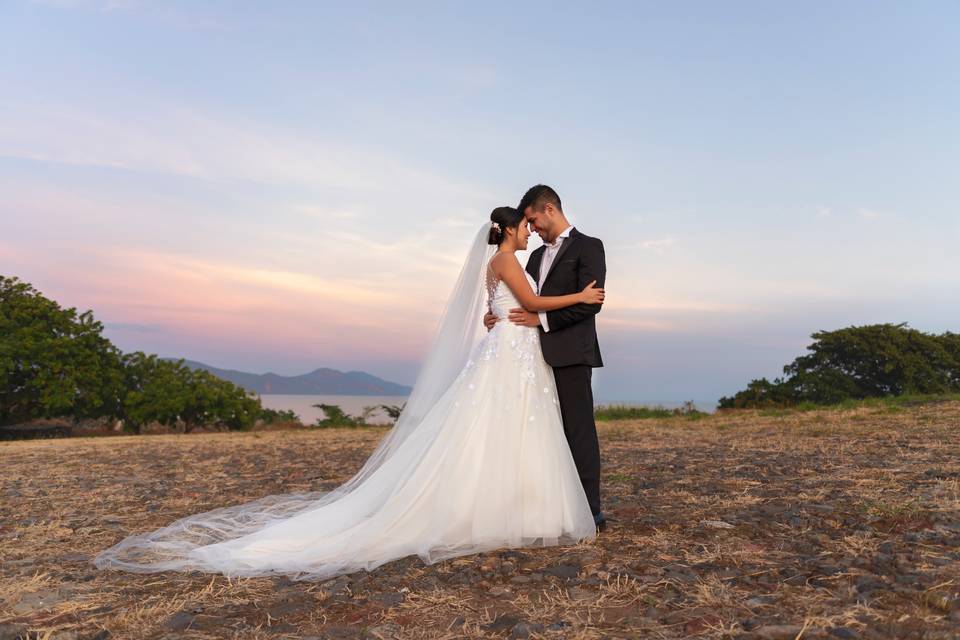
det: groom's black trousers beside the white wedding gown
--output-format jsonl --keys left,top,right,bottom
{"left": 553, "top": 365, "right": 600, "bottom": 516}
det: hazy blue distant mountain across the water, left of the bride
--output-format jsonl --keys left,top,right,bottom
{"left": 171, "top": 358, "right": 411, "bottom": 396}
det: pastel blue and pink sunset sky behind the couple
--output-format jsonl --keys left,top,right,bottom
{"left": 0, "top": 0, "right": 960, "bottom": 404}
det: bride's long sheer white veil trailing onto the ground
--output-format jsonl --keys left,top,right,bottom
{"left": 93, "top": 224, "right": 497, "bottom": 579}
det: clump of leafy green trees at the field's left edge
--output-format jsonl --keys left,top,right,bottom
{"left": 0, "top": 276, "right": 263, "bottom": 431}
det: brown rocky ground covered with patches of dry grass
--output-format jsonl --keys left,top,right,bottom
{"left": 0, "top": 402, "right": 960, "bottom": 640}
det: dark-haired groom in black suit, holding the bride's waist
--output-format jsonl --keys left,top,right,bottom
{"left": 484, "top": 184, "right": 607, "bottom": 531}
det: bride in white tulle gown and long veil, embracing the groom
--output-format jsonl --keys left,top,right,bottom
{"left": 93, "top": 207, "right": 604, "bottom": 580}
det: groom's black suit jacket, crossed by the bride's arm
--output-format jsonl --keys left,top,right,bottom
{"left": 527, "top": 228, "right": 607, "bottom": 367}
